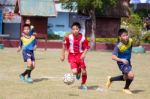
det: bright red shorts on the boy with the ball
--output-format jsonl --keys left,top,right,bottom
{"left": 68, "top": 53, "right": 86, "bottom": 69}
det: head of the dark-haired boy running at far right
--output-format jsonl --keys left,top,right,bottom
{"left": 118, "top": 29, "right": 129, "bottom": 44}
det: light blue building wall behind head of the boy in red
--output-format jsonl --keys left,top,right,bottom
{"left": 48, "top": 12, "right": 86, "bottom": 37}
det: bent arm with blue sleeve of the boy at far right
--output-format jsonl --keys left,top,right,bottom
{"left": 112, "top": 46, "right": 128, "bottom": 64}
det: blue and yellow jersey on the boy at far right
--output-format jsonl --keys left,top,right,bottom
{"left": 113, "top": 38, "right": 133, "bottom": 61}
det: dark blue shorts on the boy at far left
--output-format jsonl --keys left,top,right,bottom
{"left": 22, "top": 50, "right": 35, "bottom": 62}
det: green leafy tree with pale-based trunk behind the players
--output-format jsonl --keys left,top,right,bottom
{"left": 60, "top": 0, "right": 118, "bottom": 50}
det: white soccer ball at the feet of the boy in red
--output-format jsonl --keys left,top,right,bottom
{"left": 63, "top": 73, "right": 75, "bottom": 85}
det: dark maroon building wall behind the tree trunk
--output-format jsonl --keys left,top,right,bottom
{"left": 86, "top": 17, "right": 121, "bottom": 38}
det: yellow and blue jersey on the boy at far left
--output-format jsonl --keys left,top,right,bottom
{"left": 20, "top": 36, "right": 37, "bottom": 50}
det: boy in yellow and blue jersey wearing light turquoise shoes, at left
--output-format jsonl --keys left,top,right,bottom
{"left": 17, "top": 24, "right": 37, "bottom": 83}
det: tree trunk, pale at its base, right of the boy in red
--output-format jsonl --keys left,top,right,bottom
{"left": 89, "top": 9, "right": 96, "bottom": 50}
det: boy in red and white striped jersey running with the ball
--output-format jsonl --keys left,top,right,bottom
{"left": 60, "top": 22, "right": 89, "bottom": 90}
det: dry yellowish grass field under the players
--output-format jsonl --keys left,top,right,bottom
{"left": 0, "top": 48, "right": 150, "bottom": 99}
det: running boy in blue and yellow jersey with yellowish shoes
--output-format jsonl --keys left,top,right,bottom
{"left": 106, "top": 29, "right": 134, "bottom": 94}
